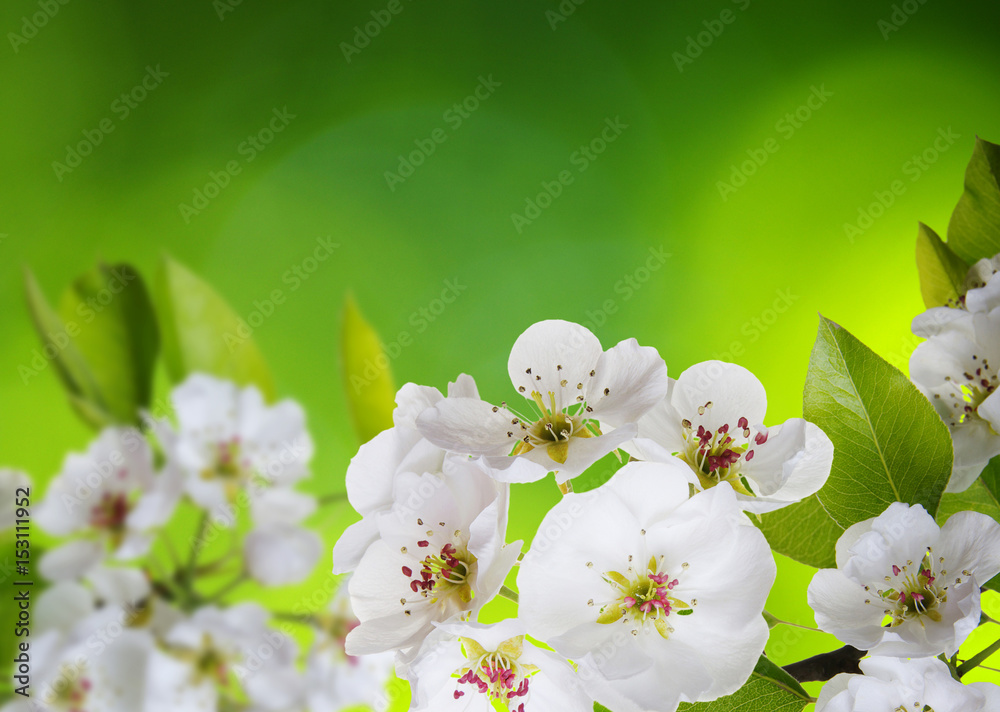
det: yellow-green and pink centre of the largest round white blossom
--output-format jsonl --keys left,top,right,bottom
{"left": 597, "top": 556, "right": 694, "bottom": 638}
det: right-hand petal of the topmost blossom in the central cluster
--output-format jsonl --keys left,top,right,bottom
{"left": 586, "top": 339, "right": 667, "bottom": 427}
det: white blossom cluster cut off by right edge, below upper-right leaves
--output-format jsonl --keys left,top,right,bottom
{"left": 910, "top": 255, "right": 1000, "bottom": 492}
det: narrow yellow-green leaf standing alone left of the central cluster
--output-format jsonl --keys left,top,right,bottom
{"left": 340, "top": 294, "right": 396, "bottom": 443}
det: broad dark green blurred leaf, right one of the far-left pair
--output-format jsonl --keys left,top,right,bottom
{"left": 59, "top": 264, "right": 159, "bottom": 423}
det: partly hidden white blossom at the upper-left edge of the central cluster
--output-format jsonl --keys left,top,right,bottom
{"left": 333, "top": 374, "right": 479, "bottom": 574}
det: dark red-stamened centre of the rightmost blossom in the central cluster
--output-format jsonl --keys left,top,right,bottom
{"left": 675, "top": 401, "right": 767, "bottom": 496}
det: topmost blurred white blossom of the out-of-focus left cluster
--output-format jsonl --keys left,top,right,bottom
{"left": 157, "top": 374, "right": 313, "bottom": 522}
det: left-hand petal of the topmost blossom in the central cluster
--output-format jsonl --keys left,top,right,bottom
{"left": 417, "top": 398, "right": 517, "bottom": 455}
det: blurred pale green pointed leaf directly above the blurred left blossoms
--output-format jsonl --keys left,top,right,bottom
{"left": 153, "top": 256, "right": 274, "bottom": 400}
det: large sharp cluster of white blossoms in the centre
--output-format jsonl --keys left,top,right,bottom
{"left": 333, "top": 321, "right": 833, "bottom": 712}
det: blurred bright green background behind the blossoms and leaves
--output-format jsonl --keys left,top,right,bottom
{"left": 0, "top": 0, "right": 1000, "bottom": 704}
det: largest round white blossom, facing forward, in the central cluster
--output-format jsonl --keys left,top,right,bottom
{"left": 517, "top": 459, "right": 776, "bottom": 712}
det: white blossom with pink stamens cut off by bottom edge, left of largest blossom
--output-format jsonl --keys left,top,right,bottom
{"left": 409, "top": 619, "right": 594, "bottom": 712}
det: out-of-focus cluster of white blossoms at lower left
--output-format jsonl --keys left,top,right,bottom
{"left": 0, "top": 374, "right": 392, "bottom": 712}
